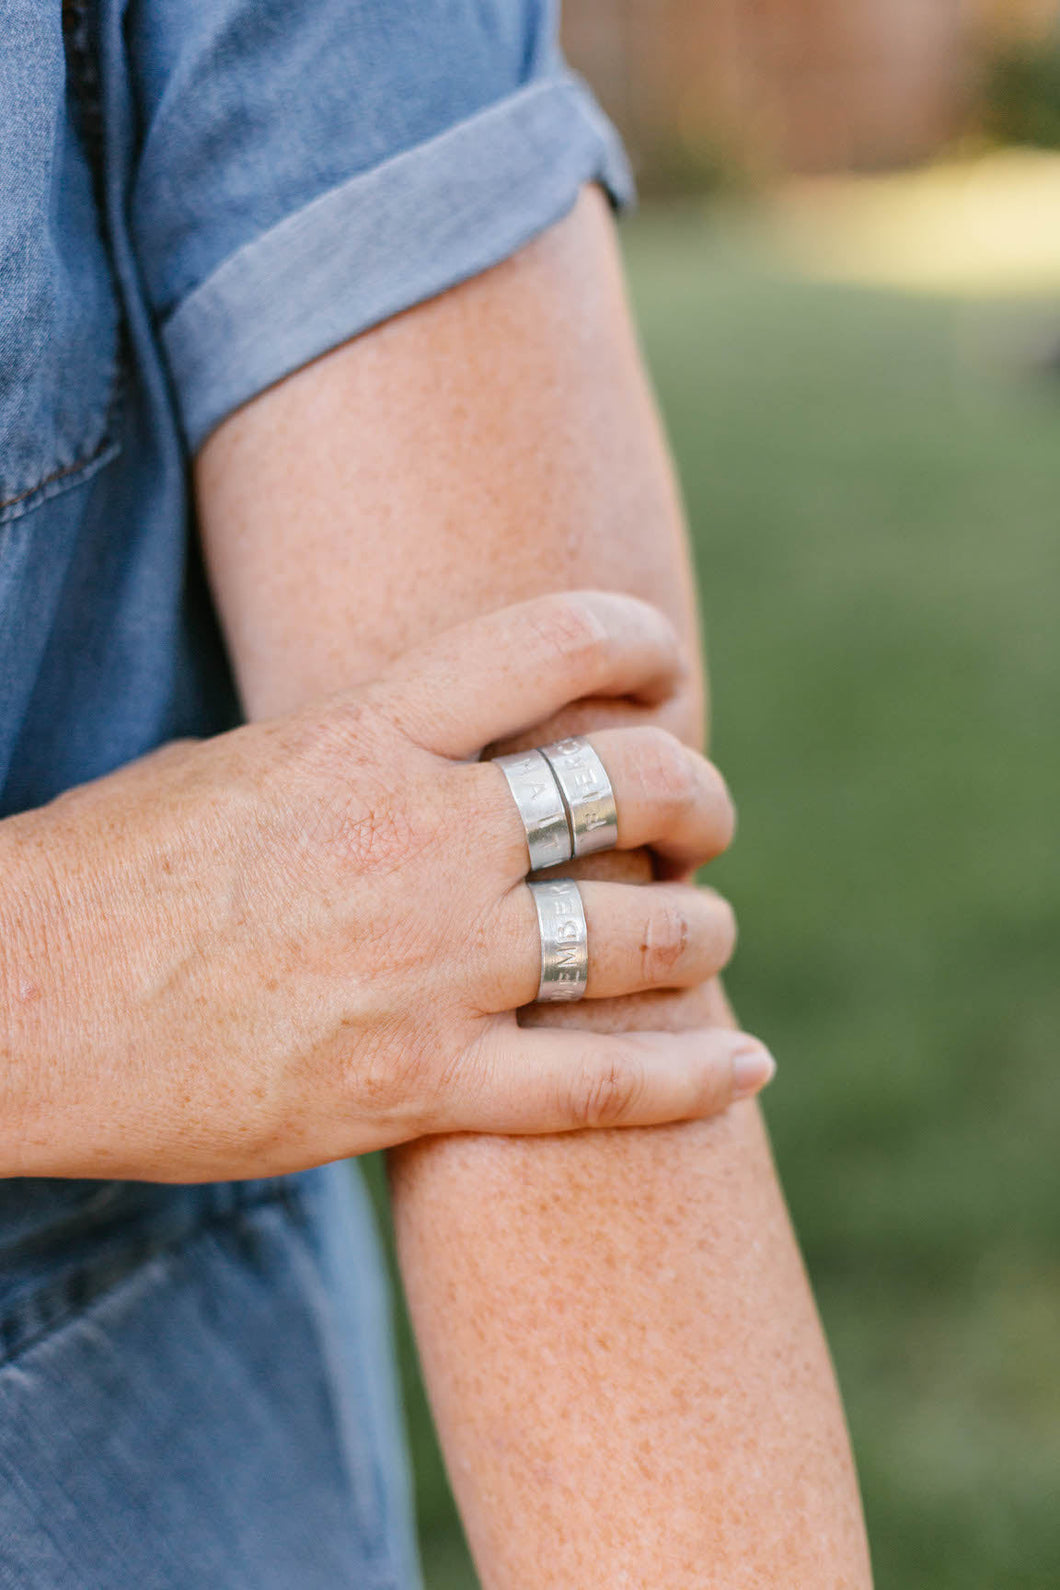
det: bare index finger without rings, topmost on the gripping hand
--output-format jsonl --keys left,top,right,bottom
{"left": 378, "top": 591, "right": 685, "bottom": 757}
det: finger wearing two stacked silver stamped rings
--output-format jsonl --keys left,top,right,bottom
{"left": 467, "top": 725, "right": 736, "bottom": 884}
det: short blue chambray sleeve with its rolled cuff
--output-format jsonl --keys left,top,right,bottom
{"left": 126, "top": 0, "right": 633, "bottom": 450}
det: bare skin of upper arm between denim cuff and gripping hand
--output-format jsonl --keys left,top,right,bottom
{"left": 197, "top": 189, "right": 701, "bottom": 738}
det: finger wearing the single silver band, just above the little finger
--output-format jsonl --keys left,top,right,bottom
{"left": 483, "top": 879, "right": 736, "bottom": 1014}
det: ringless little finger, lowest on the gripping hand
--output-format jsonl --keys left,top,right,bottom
{"left": 442, "top": 1022, "right": 776, "bottom": 1134}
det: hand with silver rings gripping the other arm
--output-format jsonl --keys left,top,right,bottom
{"left": 0, "top": 593, "right": 771, "bottom": 1181}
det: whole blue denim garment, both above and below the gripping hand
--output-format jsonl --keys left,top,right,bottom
{"left": 0, "top": 0, "right": 629, "bottom": 1590}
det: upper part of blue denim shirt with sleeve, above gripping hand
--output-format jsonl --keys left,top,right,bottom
{"left": 0, "top": 0, "right": 629, "bottom": 816}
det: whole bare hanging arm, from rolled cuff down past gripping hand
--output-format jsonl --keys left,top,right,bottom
{"left": 197, "top": 189, "right": 869, "bottom": 1590}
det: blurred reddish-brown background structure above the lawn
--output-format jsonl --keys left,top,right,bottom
{"left": 564, "top": 0, "right": 1060, "bottom": 180}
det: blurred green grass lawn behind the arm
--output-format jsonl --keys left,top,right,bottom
{"left": 368, "top": 210, "right": 1060, "bottom": 1590}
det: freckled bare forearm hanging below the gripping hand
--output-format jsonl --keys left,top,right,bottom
{"left": 397, "top": 1081, "right": 868, "bottom": 1590}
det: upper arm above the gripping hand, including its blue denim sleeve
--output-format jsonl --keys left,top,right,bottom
{"left": 127, "top": 0, "right": 689, "bottom": 733}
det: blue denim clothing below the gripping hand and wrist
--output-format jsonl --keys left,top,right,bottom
{"left": 0, "top": 1164, "right": 420, "bottom": 1590}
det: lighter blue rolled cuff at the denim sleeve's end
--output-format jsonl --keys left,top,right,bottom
{"left": 162, "top": 73, "right": 634, "bottom": 452}
